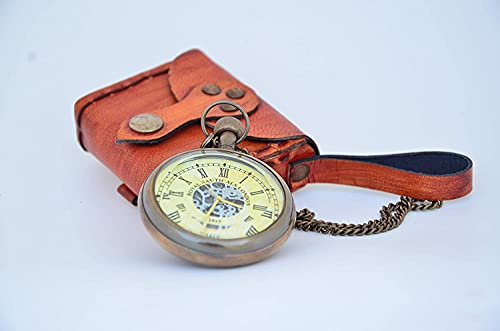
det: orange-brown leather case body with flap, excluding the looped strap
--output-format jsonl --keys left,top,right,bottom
{"left": 75, "top": 50, "right": 318, "bottom": 202}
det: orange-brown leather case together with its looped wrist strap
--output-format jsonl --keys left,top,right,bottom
{"left": 75, "top": 50, "right": 472, "bottom": 204}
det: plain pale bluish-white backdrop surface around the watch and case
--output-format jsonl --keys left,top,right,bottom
{"left": 0, "top": 0, "right": 500, "bottom": 331}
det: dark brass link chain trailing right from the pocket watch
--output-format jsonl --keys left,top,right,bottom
{"left": 295, "top": 196, "right": 443, "bottom": 236}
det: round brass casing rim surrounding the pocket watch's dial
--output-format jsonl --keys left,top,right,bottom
{"left": 138, "top": 148, "right": 296, "bottom": 267}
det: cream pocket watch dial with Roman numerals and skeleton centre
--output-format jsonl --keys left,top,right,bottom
{"left": 154, "top": 152, "right": 284, "bottom": 239}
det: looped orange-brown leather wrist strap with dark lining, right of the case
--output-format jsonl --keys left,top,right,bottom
{"left": 288, "top": 152, "right": 472, "bottom": 200}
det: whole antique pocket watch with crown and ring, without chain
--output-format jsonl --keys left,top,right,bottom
{"left": 138, "top": 100, "right": 296, "bottom": 267}
